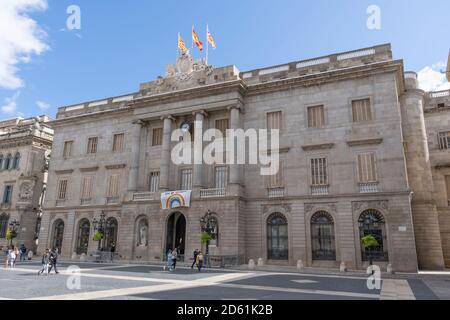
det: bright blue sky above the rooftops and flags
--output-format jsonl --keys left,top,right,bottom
{"left": 0, "top": 0, "right": 450, "bottom": 119}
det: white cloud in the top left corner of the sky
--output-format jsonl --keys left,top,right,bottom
{"left": 0, "top": 0, "right": 49, "bottom": 90}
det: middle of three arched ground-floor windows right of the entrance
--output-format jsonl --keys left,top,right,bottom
{"left": 311, "top": 211, "right": 336, "bottom": 260}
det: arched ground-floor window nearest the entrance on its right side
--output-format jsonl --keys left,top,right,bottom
{"left": 267, "top": 213, "right": 289, "bottom": 260}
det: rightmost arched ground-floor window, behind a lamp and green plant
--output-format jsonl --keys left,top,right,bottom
{"left": 358, "top": 209, "right": 388, "bottom": 261}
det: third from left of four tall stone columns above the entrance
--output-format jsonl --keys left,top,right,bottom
{"left": 193, "top": 111, "right": 206, "bottom": 189}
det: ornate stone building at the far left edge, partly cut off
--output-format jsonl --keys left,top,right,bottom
{"left": 0, "top": 116, "right": 53, "bottom": 252}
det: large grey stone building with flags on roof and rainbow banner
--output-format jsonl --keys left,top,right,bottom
{"left": 39, "top": 45, "right": 450, "bottom": 271}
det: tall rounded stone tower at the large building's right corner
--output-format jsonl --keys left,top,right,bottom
{"left": 401, "top": 71, "right": 444, "bottom": 269}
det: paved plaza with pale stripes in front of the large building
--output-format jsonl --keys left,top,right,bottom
{"left": 0, "top": 261, "right": 450, "bottom": 300}
